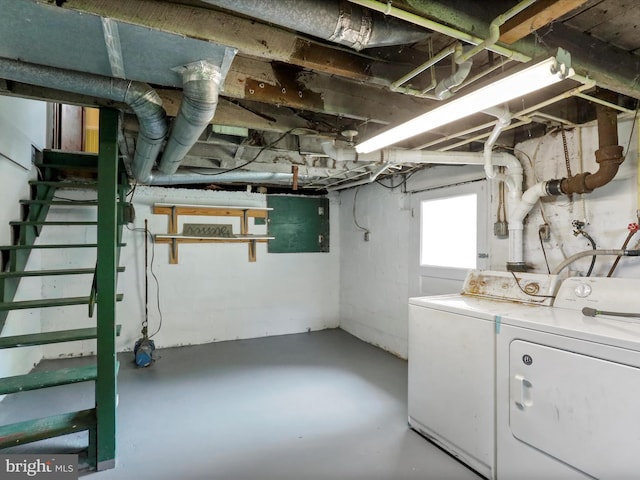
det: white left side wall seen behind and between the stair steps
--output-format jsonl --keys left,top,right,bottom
{"left": 0, "top": 96, "right": 47, "bottom": 386}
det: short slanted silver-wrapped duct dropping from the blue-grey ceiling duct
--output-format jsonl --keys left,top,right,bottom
{"left": 158, "top": 61, "right": 222, "bottom": 175}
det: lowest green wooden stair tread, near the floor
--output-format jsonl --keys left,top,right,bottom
{"left": 0, "top": 408, "right": 96, "bottom": 448}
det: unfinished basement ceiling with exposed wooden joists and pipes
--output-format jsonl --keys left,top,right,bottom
{"left": 0, "top": 0, "right": 640, "bottom": 192}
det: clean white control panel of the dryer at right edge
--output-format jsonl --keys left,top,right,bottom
{"left": 553, "top": 277, "right": 640, "bottom": 313}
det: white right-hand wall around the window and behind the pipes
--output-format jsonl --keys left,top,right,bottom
{"left": 340, "top": 115, "right": 640, "bottom": 357}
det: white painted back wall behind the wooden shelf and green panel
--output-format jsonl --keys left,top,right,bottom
{"left": 43, "top": 186, "right": 340, "bottom": 358}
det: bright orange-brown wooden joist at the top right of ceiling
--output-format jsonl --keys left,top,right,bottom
{"left": 500, "top": 0, "right": 588, "bottom": 45}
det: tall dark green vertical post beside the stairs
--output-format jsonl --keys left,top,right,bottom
{"left": 96, "top": 108, "right": 118, "bottom": 470}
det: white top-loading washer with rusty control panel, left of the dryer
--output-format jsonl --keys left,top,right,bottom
{"left": 408, "top": 271, "right": 557, "bottom": 478}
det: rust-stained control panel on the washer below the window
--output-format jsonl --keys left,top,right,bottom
{"left": 462, "top": 270, "right": 558, "bottom": 306}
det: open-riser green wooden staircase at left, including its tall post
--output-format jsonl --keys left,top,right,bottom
{"left": 0, "top": 109, "right": 128, "bottom": 470}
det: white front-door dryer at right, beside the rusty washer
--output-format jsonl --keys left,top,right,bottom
{"left": 496, "top": 278, "right": 640, "bottom": 480}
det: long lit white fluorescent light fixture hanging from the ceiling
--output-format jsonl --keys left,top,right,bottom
{"left": 356, "top": 49, "right": 575, "bottom": 153}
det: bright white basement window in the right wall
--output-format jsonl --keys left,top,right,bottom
{"left": 420, "top": 193, "right": 478, "bottom": 269}
